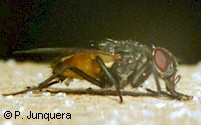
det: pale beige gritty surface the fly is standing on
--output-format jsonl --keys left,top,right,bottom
{"left": 0, "top": 60, "right": 201, "bottom": 125}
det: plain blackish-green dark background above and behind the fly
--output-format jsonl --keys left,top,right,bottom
{"left": 0, "top": 0, "right": 201, "bottom": 64}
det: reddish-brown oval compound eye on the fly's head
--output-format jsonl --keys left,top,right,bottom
{"left": 154, "top": 48, "right": 171, "bottom": 72}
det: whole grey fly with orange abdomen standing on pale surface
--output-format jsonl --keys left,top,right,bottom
{"left": 4, "top": 39, "right": 191, "bottom": 102}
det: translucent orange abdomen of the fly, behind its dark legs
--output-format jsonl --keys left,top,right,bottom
{"left": 53, "top": 51, "right": 120, "bottom": 79}
